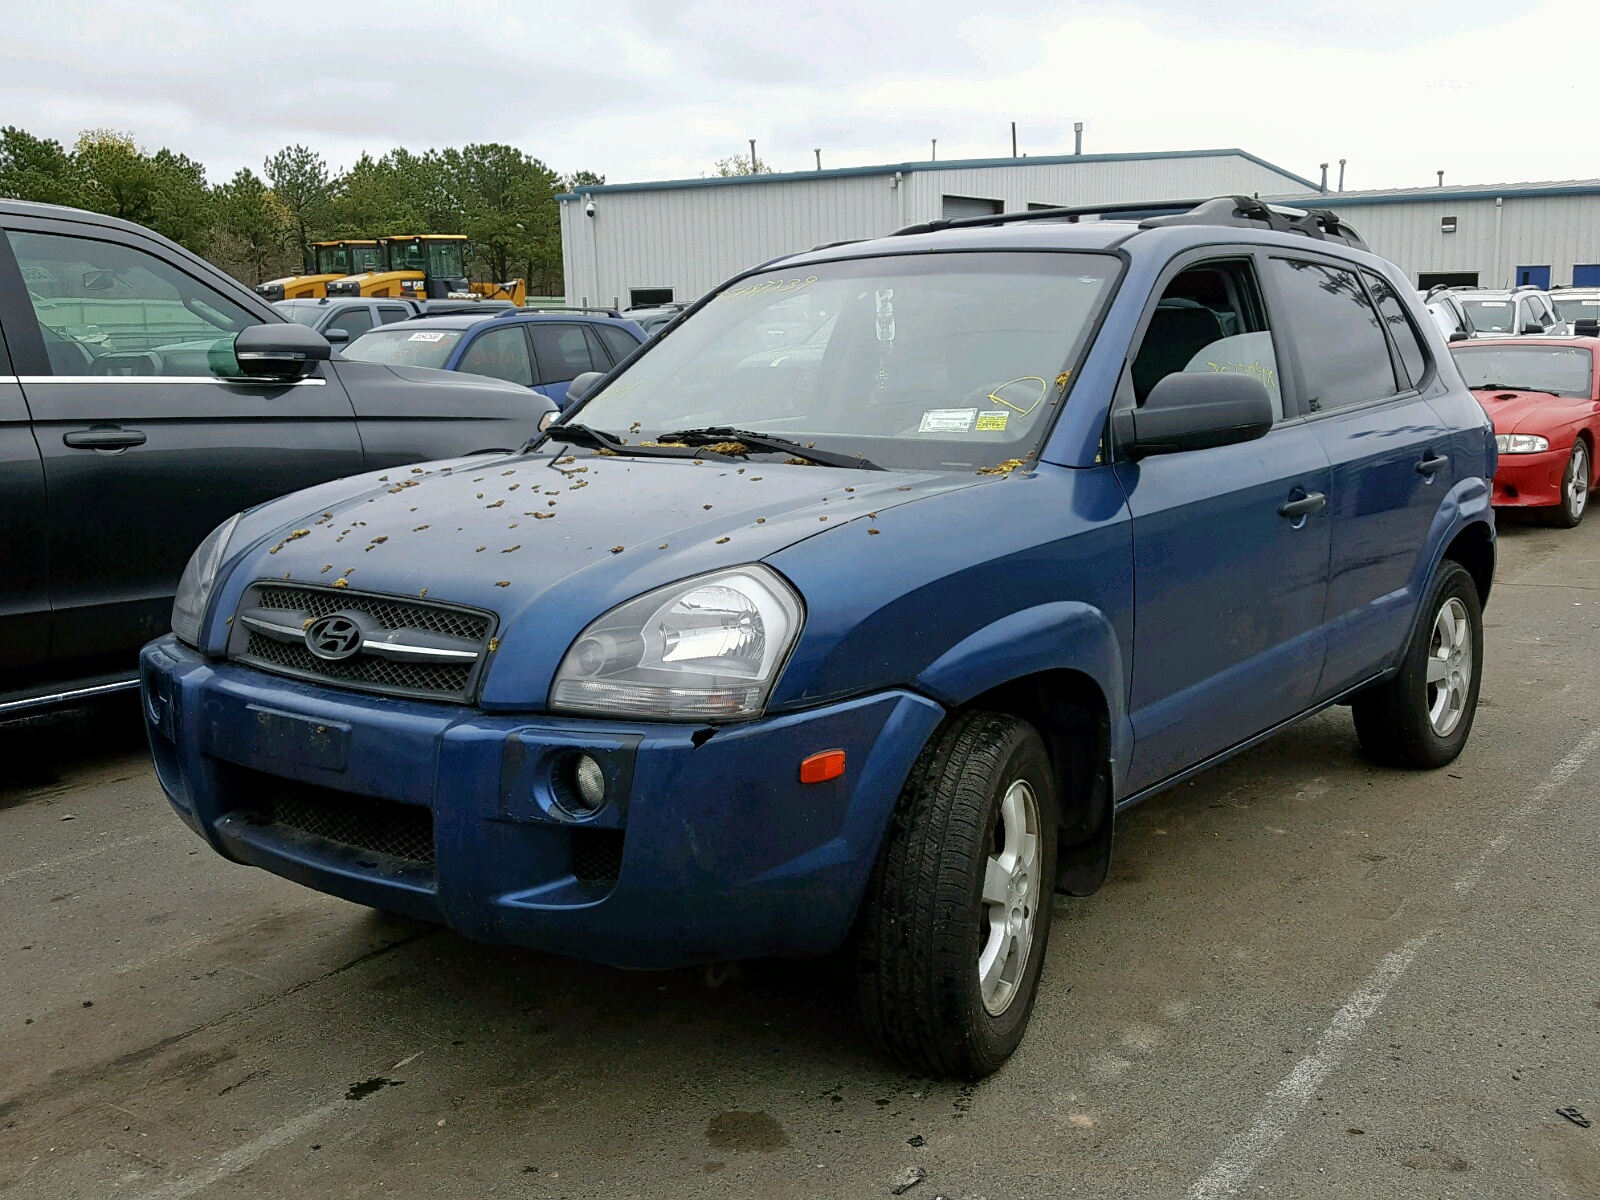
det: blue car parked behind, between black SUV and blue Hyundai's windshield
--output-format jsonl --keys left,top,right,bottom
{"left": 342, "top": 309, "right": 646, "bottom": 406}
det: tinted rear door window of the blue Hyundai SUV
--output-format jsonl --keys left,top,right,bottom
{"left": 1269, "top": 258, "right": 1398, "bottom": 413}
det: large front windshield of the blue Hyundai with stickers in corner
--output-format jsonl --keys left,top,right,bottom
{"left": 573, "top": 253, "right": 1120, "bottom": 470}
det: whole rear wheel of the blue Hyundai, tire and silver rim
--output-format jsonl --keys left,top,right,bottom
{"left": 1350, "top": 558, "right": 1483, "bottom": 768}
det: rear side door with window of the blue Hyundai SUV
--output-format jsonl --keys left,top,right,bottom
{"left": 1266, "top": 253, "right": 1454, "bottom": 698}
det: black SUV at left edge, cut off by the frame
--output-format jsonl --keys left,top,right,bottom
{"left": 0, "top": 200, "right": 554, "bottom": 720}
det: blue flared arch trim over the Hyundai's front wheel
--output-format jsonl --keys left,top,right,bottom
{"left": 917, "top": 600, "right": 1133, "bottom": 786}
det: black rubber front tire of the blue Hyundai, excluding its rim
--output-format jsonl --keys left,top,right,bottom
{"left": 856, "top": 712, "right": 1058, "bottom": 1080}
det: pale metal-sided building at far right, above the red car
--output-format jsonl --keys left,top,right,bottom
{"left": 1282, "top": 179, "right": 1600, "bottom": 288}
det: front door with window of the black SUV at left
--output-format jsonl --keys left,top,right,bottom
{"left": 0, "top": 214, "right": 363, "bottom": 670}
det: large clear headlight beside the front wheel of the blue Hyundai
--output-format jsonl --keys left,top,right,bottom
{"left": 550, "top": 565, "right": 802, "bottom": 722}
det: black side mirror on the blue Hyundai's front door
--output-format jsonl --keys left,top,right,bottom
{"left": 1112, "top": 371, "right": 1274, "bottom": 458}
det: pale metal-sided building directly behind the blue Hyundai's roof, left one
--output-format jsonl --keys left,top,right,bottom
{"left": 562, "top": 149, "right": 1317, "bottom": 306}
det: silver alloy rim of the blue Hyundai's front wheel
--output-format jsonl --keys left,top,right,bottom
{"left": 978, "top": 779, "right": 1042, "bottom": 1016}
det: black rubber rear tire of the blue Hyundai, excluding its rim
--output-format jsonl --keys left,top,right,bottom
{"left": 1350, "top": 558, "right": 1483, "bottom": 768}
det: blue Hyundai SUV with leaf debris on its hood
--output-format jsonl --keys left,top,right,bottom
{"left": 142, "top": 197, "right": 1494, "bottom": 1078}
